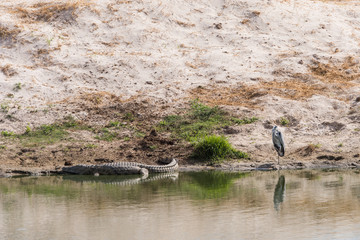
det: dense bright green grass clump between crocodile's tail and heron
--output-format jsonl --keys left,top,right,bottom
{"left": 193, "top": 135, "right": 249, "bottom": 162}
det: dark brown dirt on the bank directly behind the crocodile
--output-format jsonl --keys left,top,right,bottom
{"left": 0, "top": 96, "right": 192, "bottom": 172}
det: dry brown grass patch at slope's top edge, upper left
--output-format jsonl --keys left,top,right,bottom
{"left": 14, "top": 0, "right": 90, "bottom": 23}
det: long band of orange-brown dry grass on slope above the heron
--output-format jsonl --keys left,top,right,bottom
{"left": 190, "top": 57, "right": 360, "bottom": 108}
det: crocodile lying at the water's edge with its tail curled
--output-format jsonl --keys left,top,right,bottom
{"left": 62, "top": 158, "right": 179, "bottom": 176}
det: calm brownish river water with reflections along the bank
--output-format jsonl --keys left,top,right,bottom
{"left": 0, "top": 170, "right": 360, "bottom": 240}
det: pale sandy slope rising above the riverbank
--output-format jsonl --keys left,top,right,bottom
{"left": 0, "top": 0, "right": 360, "bottom": 170}
